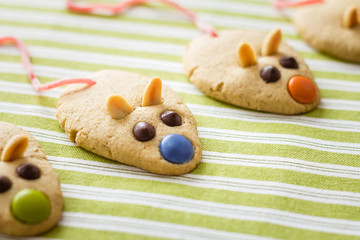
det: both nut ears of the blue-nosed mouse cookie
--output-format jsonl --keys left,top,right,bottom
{"left": 106, "top": 77, "right": 162, "bottom": 119}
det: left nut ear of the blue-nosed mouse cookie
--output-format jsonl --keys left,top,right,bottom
{"left": 106, "top": 95, "right": 134, "bottom": 119}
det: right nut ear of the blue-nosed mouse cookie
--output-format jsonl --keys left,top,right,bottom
{"left": 142, "top": 77, "right": 162, "bottom": 107}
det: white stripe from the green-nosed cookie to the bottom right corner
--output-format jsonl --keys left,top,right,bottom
{"left": 61, "top": 184, "right": 360, "bottom": 234}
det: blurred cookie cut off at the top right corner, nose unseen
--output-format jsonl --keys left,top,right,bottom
{"left": 294, "top": 0, "right": 360, "bottom": 63}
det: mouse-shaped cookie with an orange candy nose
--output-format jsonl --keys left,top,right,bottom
{"left": 183, "top": 29, "right": 320, "bottom": 114}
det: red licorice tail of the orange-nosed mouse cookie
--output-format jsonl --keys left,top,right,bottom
{"left": 66, "top": 0, "right": 218, "bottom": 37}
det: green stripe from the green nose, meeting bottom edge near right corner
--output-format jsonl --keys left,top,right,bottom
{"left": 59, "top": 198, "right": 358, "bottom": 239}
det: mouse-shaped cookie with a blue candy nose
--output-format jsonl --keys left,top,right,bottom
{"left": 56, "top": 70, "right": 201, "bottom": 175}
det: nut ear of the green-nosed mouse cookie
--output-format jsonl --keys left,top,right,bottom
{"left": 1, "top": 135, "right": 29, "bottom": 162}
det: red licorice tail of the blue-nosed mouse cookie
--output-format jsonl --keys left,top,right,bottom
{"left": 0, "top": 36, "right": 96, "bottom": 92}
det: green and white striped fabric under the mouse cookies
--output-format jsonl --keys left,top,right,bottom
{"left": 0, "top": 0, "right": 360, "bottom": 240}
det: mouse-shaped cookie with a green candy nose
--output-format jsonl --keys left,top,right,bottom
{"left": 0, "top": 122, "right": 63, "bottom": 236}
